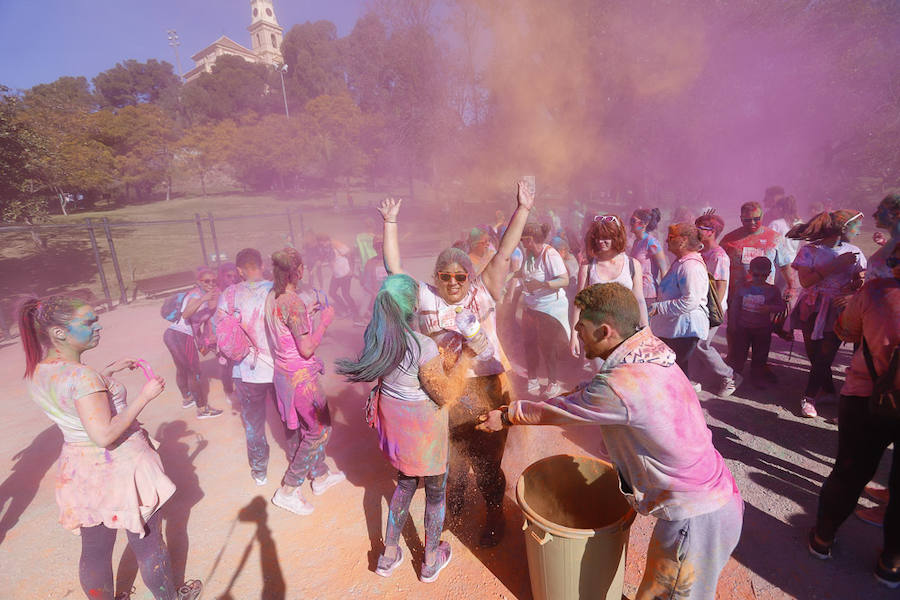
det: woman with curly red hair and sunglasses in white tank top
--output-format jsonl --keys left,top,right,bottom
{"left": 569, "top": 215, "right": 647, "bottom": 358}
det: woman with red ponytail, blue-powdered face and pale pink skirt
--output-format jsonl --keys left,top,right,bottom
{"left": 19, "top": 296, "right": 203, "bottom": 600}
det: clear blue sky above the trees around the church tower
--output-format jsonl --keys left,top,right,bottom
{"left": 0, "top": 0, "right": 365, "bottom": 89}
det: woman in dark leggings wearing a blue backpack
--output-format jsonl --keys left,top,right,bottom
{"left": 163, "top": 267, "right": 222, "bottom": 419}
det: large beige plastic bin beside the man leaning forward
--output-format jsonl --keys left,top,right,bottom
{"left": 516, "top": 454, "right": 635, "bottom": 600}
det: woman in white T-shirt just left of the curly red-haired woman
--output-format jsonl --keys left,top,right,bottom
{"left": 521, "top": 222, "right": 571, "bottom": 398}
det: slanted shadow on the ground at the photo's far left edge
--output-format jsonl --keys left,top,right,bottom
{"left": 0, "top": 425, "right": 63, "bottom": 543}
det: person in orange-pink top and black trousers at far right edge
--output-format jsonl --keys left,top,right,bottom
{"left": 809, "top": 246, "right": 900, "bottom": 588}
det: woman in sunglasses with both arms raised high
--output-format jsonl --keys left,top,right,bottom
{"left": 378, "top": 181, "right": 534, "bottom": 547}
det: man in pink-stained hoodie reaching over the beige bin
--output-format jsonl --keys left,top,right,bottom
{"left": 479, "top": 283, "right": 744, "bottom": 600}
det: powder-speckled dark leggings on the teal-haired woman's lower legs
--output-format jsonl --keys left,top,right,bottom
{"left": 384, "top": 471, "right": 447, "bottom": 557}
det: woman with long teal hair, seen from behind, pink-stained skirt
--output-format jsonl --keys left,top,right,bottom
{"left": 337, "top": 275, "right": 471, "bottom": 583}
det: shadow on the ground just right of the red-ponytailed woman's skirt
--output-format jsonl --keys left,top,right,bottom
{"left": 116, "top": 420, "right": 209, "bottom": 590}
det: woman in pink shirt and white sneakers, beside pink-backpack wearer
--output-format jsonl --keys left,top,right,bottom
{"left": 265, "top": 248, "right": 345, "bottom": 515}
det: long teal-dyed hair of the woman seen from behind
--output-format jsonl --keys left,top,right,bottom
{"left": 336, "top": 275, "right": 419, "bottom": 382}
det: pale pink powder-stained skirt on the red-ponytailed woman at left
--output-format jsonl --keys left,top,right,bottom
{"left": 56, "top": 430, "right": 175, "bottom": 537}
